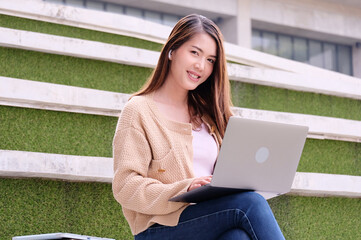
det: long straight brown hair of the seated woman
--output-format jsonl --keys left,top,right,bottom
{"left": 134, "top": 14, "right": 232, "bottom": 138}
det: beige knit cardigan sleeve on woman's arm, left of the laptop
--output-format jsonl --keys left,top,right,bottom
{"left": 112, "top": 105, "right": 193, "bottom": 215}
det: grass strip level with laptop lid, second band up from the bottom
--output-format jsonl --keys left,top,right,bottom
{"left": 0, "top": 106, "right": 361, "bottom": 175}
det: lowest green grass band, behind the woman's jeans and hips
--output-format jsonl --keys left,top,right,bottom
{"left": 0, "top": 179, "right": 361, "bottom": 240}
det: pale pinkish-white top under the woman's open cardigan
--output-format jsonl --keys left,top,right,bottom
{"left": 192, "top": 123, "right": 218, "bottom": 177}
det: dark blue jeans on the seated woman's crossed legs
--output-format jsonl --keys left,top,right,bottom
{"left": 134, "top": 192, "right": 285, "bottom": 240}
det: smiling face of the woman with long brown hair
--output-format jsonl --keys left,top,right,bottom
{"left": 167, "top": 33, "right": 217, "bottom": 91}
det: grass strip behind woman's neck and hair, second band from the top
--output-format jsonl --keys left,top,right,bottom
{"left": 0, "top": 48, "right": 361, "bottom": 120}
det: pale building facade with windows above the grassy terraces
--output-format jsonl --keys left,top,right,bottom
{"left": 45, "top": 0, "right": 361, "bottom": 78}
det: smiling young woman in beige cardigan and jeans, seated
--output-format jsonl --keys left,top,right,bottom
{"left": 113, "top": 14, "right": 284, "bottom": 240}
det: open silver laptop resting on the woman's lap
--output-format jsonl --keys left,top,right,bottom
{"left": 170, "top": 117, "right": 308, "bottom": 203}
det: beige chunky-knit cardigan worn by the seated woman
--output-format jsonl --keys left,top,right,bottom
{"left": 112, "top": 94, "right": 221, "bottom": 235}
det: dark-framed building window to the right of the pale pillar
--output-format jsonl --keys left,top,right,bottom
{"left": 252, "top": 29, "right": 352, "bottom": 75}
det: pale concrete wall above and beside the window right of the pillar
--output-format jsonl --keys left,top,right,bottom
{"left": 251, "top": 0, "right": 361, "bottom": 78}
